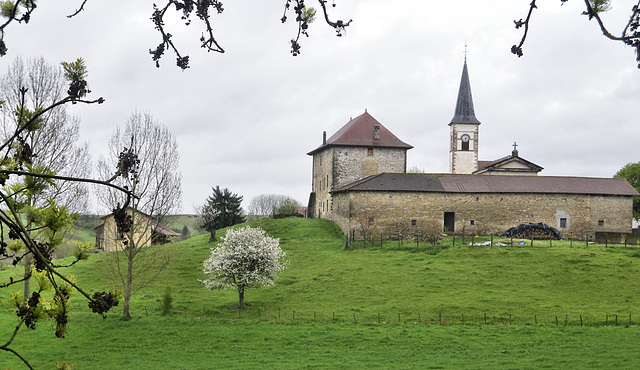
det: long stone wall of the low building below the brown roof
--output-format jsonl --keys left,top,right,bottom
{"left": 331, "top": 192, "right": 632, "bottom": 239}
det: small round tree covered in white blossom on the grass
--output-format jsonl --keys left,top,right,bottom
{"left": 200, "top": 226, "right": 287, "bottom": 308}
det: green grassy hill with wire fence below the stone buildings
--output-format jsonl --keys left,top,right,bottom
{"left": 0, "top": 218, "right": 640, "bottom": 368}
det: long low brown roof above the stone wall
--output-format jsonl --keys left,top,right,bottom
{"left": 334, "top": 173, "right": 640, "bottom": 196}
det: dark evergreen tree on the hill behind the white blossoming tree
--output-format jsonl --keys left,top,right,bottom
{"left": 199, "top": 185, "right": 244, "bottom": 241}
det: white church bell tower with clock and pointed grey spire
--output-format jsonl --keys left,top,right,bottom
{"left": 449, "top": 57, "right": 480, "bottom": 174}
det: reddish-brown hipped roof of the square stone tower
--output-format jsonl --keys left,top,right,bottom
{"left": 307, "top": 110, "right": 413, "bottom": 155}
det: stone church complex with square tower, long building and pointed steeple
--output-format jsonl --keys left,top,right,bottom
{"left": 307, "top": 60, "right": 640, "bottom": 239}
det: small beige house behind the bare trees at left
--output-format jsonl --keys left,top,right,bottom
{"left": 94, "top": 208, "right": 180, "bottom": 252}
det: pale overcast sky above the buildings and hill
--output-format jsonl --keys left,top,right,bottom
{"left": 0, "top": 0, "right": 640, "bottom": 213}
